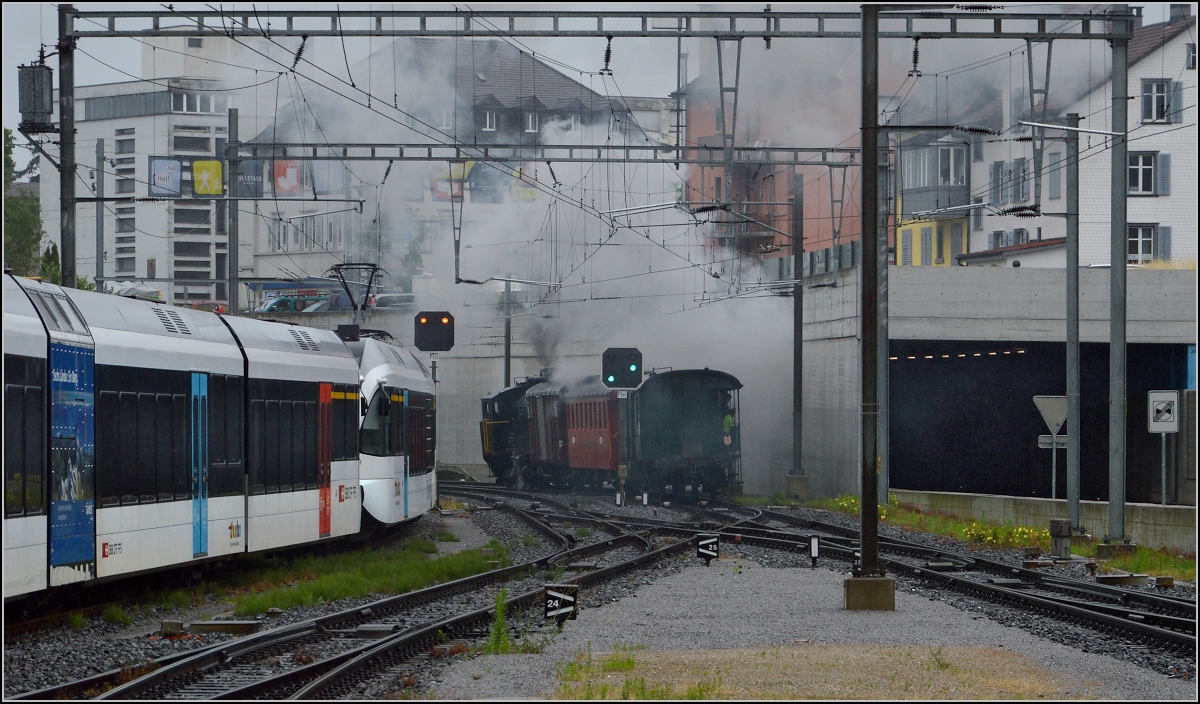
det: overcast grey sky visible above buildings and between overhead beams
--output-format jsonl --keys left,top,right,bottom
{"left": 2, "top": 2, "right": 1169, "bottom": 170}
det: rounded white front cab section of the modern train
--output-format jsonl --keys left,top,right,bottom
{"left": 346, "top": 331, "right": 437, "bottom": 525}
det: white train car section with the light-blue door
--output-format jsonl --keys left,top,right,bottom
{"left": 67, "top": 280, "right": 245, "bottom": 578}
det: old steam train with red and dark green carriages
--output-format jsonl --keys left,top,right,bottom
{"left": 480, "top": 368, "right": 742, "bottom": 497}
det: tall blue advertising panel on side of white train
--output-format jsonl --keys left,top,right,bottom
{"left": 50, "top": 343, "right": 96, "bottom": 585}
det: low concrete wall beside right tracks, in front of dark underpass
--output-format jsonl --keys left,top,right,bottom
{"left": 892, "top": 489, "right": 1196, "bottom": 555}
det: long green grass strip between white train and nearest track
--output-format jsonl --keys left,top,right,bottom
{"left": 234, "top": 540, "right": 509, "bottom": 616}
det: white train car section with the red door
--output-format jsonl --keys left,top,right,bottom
{"left": 222, "top": 317, "right": 361, "bottom": 552}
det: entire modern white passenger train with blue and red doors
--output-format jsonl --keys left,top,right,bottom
{"left": 4, "top": 275, "right": 437, "bottom": 601}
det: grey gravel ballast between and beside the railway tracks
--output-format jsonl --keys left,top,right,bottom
{"left": 4, "top": 506, "right": 1196, "bottom": 700}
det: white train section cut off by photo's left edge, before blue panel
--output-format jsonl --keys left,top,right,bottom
{"left": 4, "top": 276, "right": 49, "bottom": 600}
